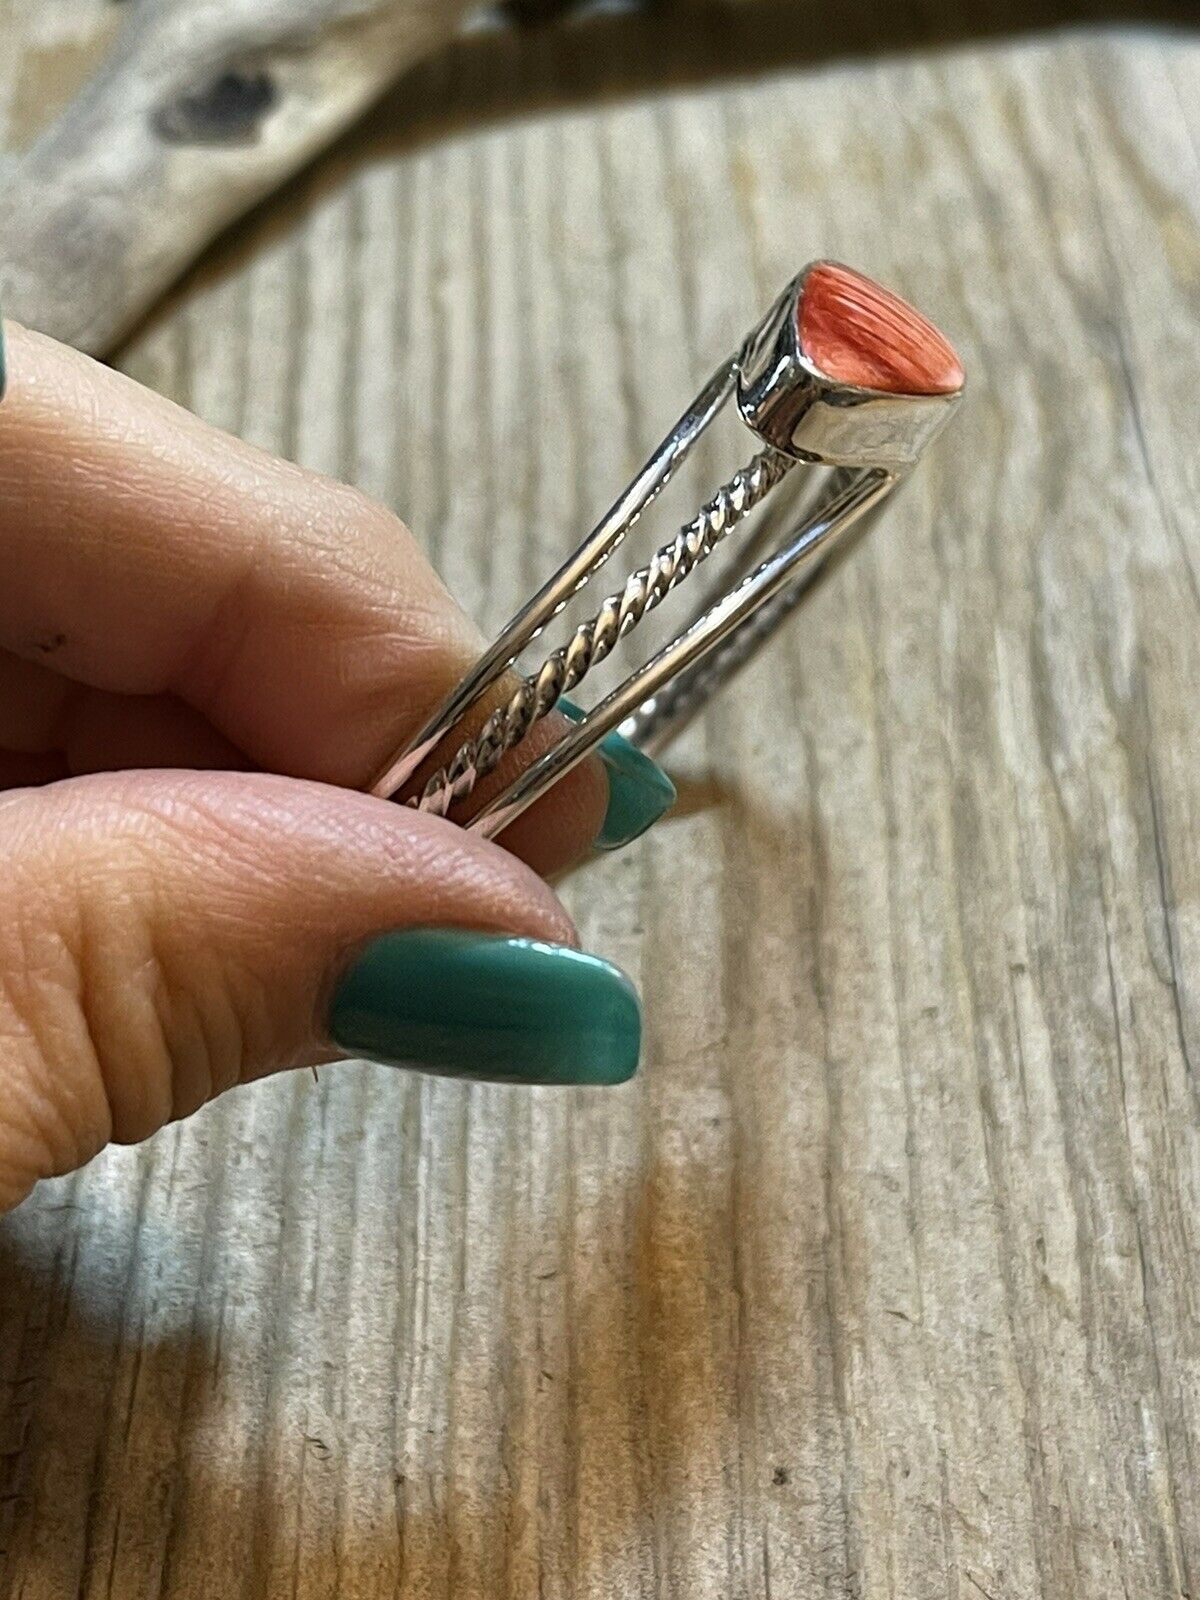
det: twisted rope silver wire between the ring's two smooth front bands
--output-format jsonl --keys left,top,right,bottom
{"left": 408, "top": 450, "right": 794, "bottom": 816}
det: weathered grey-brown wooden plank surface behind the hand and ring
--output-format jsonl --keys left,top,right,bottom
{"left": 0, "top": 0, "right": 1200, "bottom": 1600}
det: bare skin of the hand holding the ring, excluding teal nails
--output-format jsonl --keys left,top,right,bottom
{"left": 0, "top": 325, "right": 606, "bottom": 1210}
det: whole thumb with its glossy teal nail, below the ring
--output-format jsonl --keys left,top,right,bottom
{"left": 0, "top": 771, "right": 640, "bottom": 1210}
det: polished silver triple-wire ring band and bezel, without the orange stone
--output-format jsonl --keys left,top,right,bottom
{"left": 371, "top": 267, "right": 962, "bottom": 837}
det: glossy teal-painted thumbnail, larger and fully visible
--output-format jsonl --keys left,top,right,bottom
{"left": 330, "top": 928, "right": 642, "bottom": 1085}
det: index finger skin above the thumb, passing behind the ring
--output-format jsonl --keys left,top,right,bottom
{"left": 0, "top": 326, "right": 620, "bottom": 866}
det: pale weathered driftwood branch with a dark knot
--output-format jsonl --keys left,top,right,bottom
{"left": 0, "top": 0, "right": 470, "bottom": 352}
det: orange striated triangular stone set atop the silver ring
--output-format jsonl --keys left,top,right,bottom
{"left": 797, "top": 261, "right": 963, "bottom": 395}
